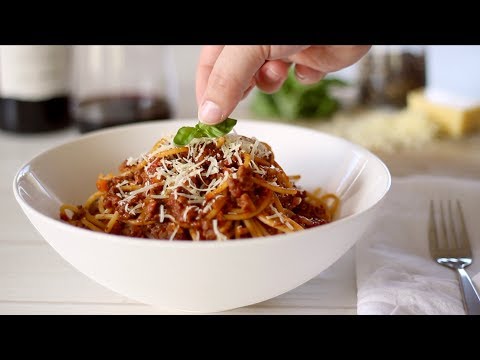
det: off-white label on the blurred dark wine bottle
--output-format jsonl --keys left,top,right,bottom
{"left": 0, "top": 45, "right": 70, "bottom": 101}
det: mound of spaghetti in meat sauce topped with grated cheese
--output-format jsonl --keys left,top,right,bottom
{"left": 60, "top": 134, "right": 339, "bottom": 241}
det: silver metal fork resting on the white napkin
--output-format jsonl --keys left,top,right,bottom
{"left": 428, "top": 200, "right": 480, "bottom": 315}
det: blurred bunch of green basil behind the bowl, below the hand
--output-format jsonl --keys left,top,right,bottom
{"left": 251, "top": 70, "right": 347, "bottom": 120}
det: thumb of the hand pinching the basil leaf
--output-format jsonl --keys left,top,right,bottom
{"left": 198, "top": 46, "right": 269, "bottom": 124}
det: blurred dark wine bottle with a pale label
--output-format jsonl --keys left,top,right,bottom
{"left": 0, "top": 45, "right": 71, "bottom": 133}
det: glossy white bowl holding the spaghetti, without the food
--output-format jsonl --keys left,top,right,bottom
{"left": 13, "top": 120, "right": 391, "bottom": 312}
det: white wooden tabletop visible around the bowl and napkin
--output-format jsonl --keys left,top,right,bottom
{"left": 0, "top": 120, "right": 480, "bottom": 314}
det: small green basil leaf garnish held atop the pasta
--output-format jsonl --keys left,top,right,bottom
{"left": 173, "top": 118, "right": 237, "bottom": 145}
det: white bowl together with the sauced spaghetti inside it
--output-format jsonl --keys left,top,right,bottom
{"left": 13, "top": 120, "right": 390, "bottom": 312}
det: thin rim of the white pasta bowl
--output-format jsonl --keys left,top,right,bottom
{"left": 12, "top": 118, "right": 392, "bottom": 248}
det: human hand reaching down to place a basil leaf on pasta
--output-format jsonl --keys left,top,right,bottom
{"left": 196, "top": 45, "right": 370, "bottom": 124}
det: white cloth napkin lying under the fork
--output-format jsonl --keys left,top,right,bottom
{"left": 356, "top": 176, "right": 480, "bottom": 315}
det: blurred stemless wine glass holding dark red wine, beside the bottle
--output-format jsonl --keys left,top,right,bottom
{"left": 71, "top": 45, "right": 178, "bottom": 133}
